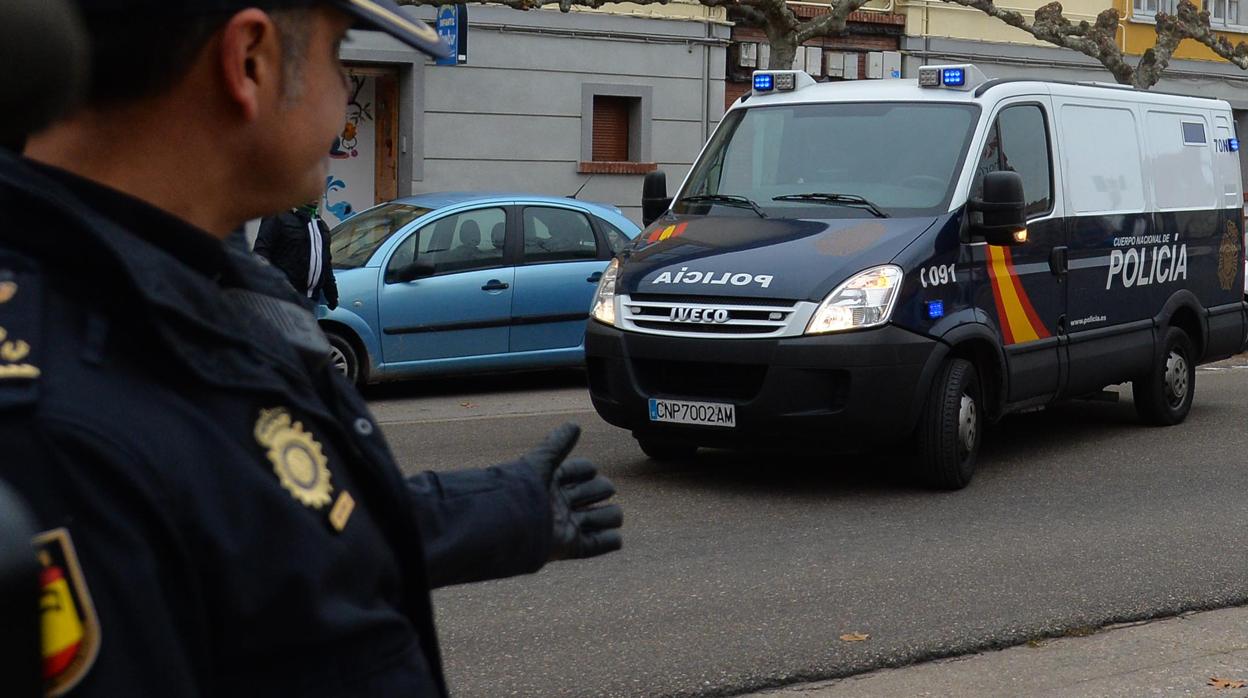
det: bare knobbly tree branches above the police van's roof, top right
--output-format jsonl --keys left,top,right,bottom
{"left": 943, "top": 0, "right": 1248, "bottom": 90}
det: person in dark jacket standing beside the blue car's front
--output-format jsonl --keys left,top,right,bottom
{"left": 252, "top": 202, "right": 338, "bottom": 310}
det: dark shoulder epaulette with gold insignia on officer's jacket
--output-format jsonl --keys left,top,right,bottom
{"left": 0, "top": 251, "right": 42, "bottom": 410}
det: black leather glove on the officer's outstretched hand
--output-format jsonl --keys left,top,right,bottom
{"left": 522, "top": 425, "right": 624, "bottom": 559}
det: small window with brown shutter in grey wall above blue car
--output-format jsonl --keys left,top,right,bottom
{"left": 577, "top": 84, "right": 658, "bottom": 175}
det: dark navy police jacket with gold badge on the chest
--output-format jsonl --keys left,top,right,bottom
{"left": 0, "top": 155, "right": 552, "bottom": 697}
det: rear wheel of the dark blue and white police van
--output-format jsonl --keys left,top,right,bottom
{"left": 1131, "top": 327, "right": 1196, "bottom": 427}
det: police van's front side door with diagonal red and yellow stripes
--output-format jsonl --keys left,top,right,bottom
{"left": 971, "top": 96, "right": 1066, "bottom": 402}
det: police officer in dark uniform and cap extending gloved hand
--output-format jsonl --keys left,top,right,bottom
{"left": 0, "top": 0, "right": 622, "bottom": 697}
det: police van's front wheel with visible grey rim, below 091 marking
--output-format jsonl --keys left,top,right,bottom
{"left": 915, "top": 358, "right": 985, "bottom": 489}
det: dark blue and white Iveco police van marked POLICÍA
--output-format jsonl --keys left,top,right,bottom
{"left": 585, "top": 65, "right": 1248, "bottom": 488}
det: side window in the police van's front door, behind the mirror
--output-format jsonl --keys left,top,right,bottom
{"left": 971, "top": 105, "right": 1053, "bottom": 217}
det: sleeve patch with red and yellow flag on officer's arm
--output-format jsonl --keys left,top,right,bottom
{"left": 34, "top": 528, "right": 100, "bottom": 696}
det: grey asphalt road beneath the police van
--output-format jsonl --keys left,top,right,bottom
{"left": 371, "top": 368, "right": 1248, "bottom": 697}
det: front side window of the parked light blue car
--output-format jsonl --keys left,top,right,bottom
{"left": 386, "top": 209, "right": 507, "bottom": 281}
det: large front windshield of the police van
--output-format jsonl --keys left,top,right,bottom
{"left": 674, "top": 102, "right": 978, "bottom": 219}
